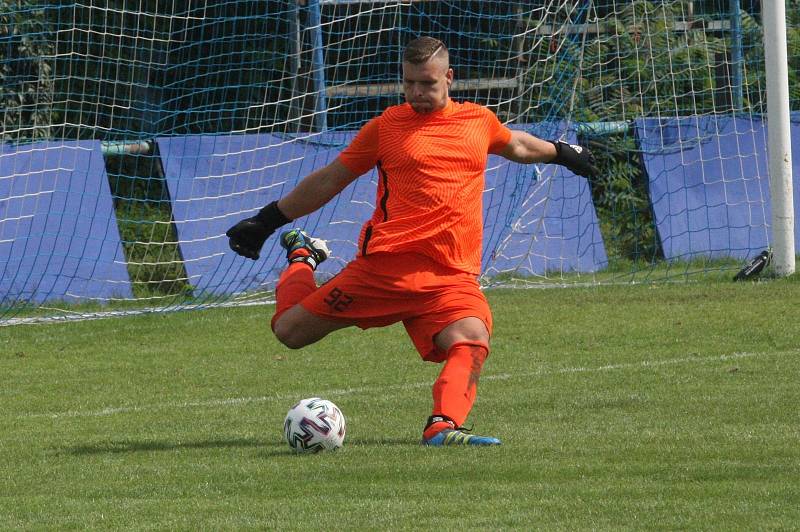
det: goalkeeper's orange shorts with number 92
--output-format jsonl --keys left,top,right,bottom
{"left": 300, "top": 253, "right": 492, "bottom": 362}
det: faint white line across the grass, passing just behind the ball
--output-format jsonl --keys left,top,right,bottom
{"left": 17, "top": 349, "right": 788, "bottom": 419}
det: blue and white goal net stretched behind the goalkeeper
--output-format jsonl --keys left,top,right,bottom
{"left": 0, "top": 0, "right": 800, "bottom": 322}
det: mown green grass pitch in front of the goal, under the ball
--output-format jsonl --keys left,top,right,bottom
{"left": 0, "top": 279, "right": 800, "bottom": 530}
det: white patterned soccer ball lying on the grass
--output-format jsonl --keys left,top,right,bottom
{"left": 283, "top": 397, "right": 346, "bottom": 453}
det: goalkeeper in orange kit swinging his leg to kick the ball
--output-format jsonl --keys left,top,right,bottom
{"left": 227, "top": 37, "right": 596, "bottom": 446}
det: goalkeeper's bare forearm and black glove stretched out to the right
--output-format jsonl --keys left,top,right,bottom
{"left": 500, "top": 131, "right": 597, "bottom": 178}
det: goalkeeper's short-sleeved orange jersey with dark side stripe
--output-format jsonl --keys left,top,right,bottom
{"left": 339, "top": 100, "right": 511, "bottom": 274}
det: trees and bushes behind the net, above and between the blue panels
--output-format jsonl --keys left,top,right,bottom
{"left": 0, "top": 0, "right": 800, "bottom": 295}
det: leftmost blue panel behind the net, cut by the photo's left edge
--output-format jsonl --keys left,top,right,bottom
{"left": 0, "top": 141, "right": 132, "bottom": 304}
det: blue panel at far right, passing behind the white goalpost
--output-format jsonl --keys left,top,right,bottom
{"left": 636, "top": 116, "right": 800, "bottom": 259}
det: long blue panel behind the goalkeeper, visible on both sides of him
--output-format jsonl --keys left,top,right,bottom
{"left": 158, "top": 131, "right": 606, "bottom": 294}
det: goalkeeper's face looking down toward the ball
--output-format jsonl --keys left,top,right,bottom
{"left": 403, "top": 56, "right": 453, "bottom": 114}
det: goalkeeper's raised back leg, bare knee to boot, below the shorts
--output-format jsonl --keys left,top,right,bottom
{"left": 272, "top": 229, "right": 348, "bottom": 349}
